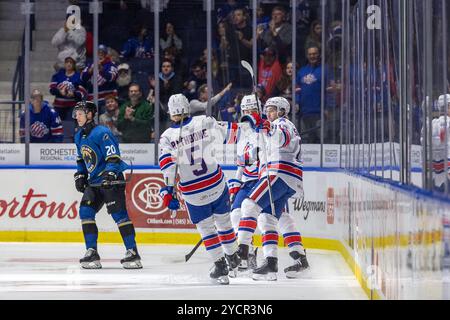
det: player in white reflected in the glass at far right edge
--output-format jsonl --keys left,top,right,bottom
{"left": 432, "top": 94, "right": 450, "bottom": 192}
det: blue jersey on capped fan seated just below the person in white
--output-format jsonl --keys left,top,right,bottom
{"left": 50, "top": 69, "right": 87, "bottom": 108}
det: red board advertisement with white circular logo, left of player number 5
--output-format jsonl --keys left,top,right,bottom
{"left": 126, "top": 174, "right": 195, "bottom": 229}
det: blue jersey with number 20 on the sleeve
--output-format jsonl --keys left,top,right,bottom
{"left": 75, "top": 126, "right": 128, "bottom": 183}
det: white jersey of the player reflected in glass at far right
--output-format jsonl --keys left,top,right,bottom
{"left": 431, "top": 116, "right": 450, "bottom": 187}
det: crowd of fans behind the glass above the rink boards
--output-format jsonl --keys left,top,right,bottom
{"left": 20, "top": 0, "right": 340, "bottom": 143}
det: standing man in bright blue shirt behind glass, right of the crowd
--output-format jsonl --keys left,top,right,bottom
{"left": 296, "top": 46, "right": 322, "bottom": 143}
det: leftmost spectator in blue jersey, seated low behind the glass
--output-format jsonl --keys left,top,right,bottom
{"left": 19, "top": 89, "right": 64, "bottom": 143}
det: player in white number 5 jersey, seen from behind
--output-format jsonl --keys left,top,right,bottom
{"left": 159, "top": 94, "right": 240, "bottom": 284}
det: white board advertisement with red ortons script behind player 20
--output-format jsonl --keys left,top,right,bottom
{"left": 0, "top": 169, "right": 117, "bottom": 231}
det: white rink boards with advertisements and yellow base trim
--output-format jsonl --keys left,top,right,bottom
{"left": 0, "top": 166, "right": 450, "bottom": 299}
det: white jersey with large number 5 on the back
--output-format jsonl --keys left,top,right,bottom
{"left": 159, "top": 115, "right": 237, "bottom": 206}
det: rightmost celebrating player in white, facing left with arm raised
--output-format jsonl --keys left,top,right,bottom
{"left": 238, "top": 97, "right": 309, "bottom": 280}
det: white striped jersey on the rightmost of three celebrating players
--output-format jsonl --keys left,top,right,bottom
{"left": 259, "top": 118, "right": 303, "bottom": 194}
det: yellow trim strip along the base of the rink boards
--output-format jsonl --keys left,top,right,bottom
{"left": 0, "top": 231, "right": 382, "bottom": 300}
